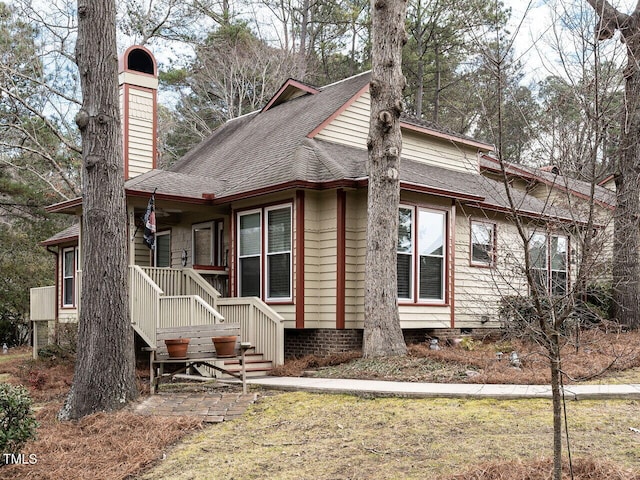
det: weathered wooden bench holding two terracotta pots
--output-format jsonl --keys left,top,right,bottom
{"left": 148, "top": 323, "right": 253, "bottom": 395}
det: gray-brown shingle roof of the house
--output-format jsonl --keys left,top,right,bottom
{"left": 126, "top": 73, "right": 570, "bottom": 218}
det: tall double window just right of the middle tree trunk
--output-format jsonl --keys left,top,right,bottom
{"left": 397, "top": 206, "right": 447, "bottom": 303}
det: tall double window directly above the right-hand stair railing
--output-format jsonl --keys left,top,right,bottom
{"left": 237, "top": 205, "right": 292, "bottom": 301}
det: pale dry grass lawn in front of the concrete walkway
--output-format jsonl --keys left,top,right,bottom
{"left": 143, "top": 392, "right": 640, "bottom": 480}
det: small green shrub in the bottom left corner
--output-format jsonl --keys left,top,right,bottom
{"left": 0, "top": 383, "right": 38, "bottom": 465}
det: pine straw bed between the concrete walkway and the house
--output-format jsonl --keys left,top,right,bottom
{"left": 273, "top": 329, "right": 640, "bottom": 384}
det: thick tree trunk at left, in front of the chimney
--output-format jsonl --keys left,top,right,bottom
{"left": 59, "top": 0, "right": 138, "bottom": 419}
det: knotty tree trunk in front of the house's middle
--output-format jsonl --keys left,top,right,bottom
{"left": 363, "top": 0, "right": 407, "bottom": 357}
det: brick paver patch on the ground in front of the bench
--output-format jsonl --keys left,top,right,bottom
{"left": 133, "top": 392, "right": 257, "bottom": 423}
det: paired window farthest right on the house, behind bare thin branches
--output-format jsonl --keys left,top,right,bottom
{"left": 529, "top": 233, "right": 569, "bottom": 295}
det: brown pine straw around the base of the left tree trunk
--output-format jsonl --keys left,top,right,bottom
{"left": 0, "top": 349, "right": 201, "bottom": 480}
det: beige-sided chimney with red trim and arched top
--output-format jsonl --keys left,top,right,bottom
{"left": 118, "top": 45, "right": 158, "bottom": 180}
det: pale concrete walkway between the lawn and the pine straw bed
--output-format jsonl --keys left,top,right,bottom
{"left": 247, "top": 377, "right": 640, "bottom": 400}
